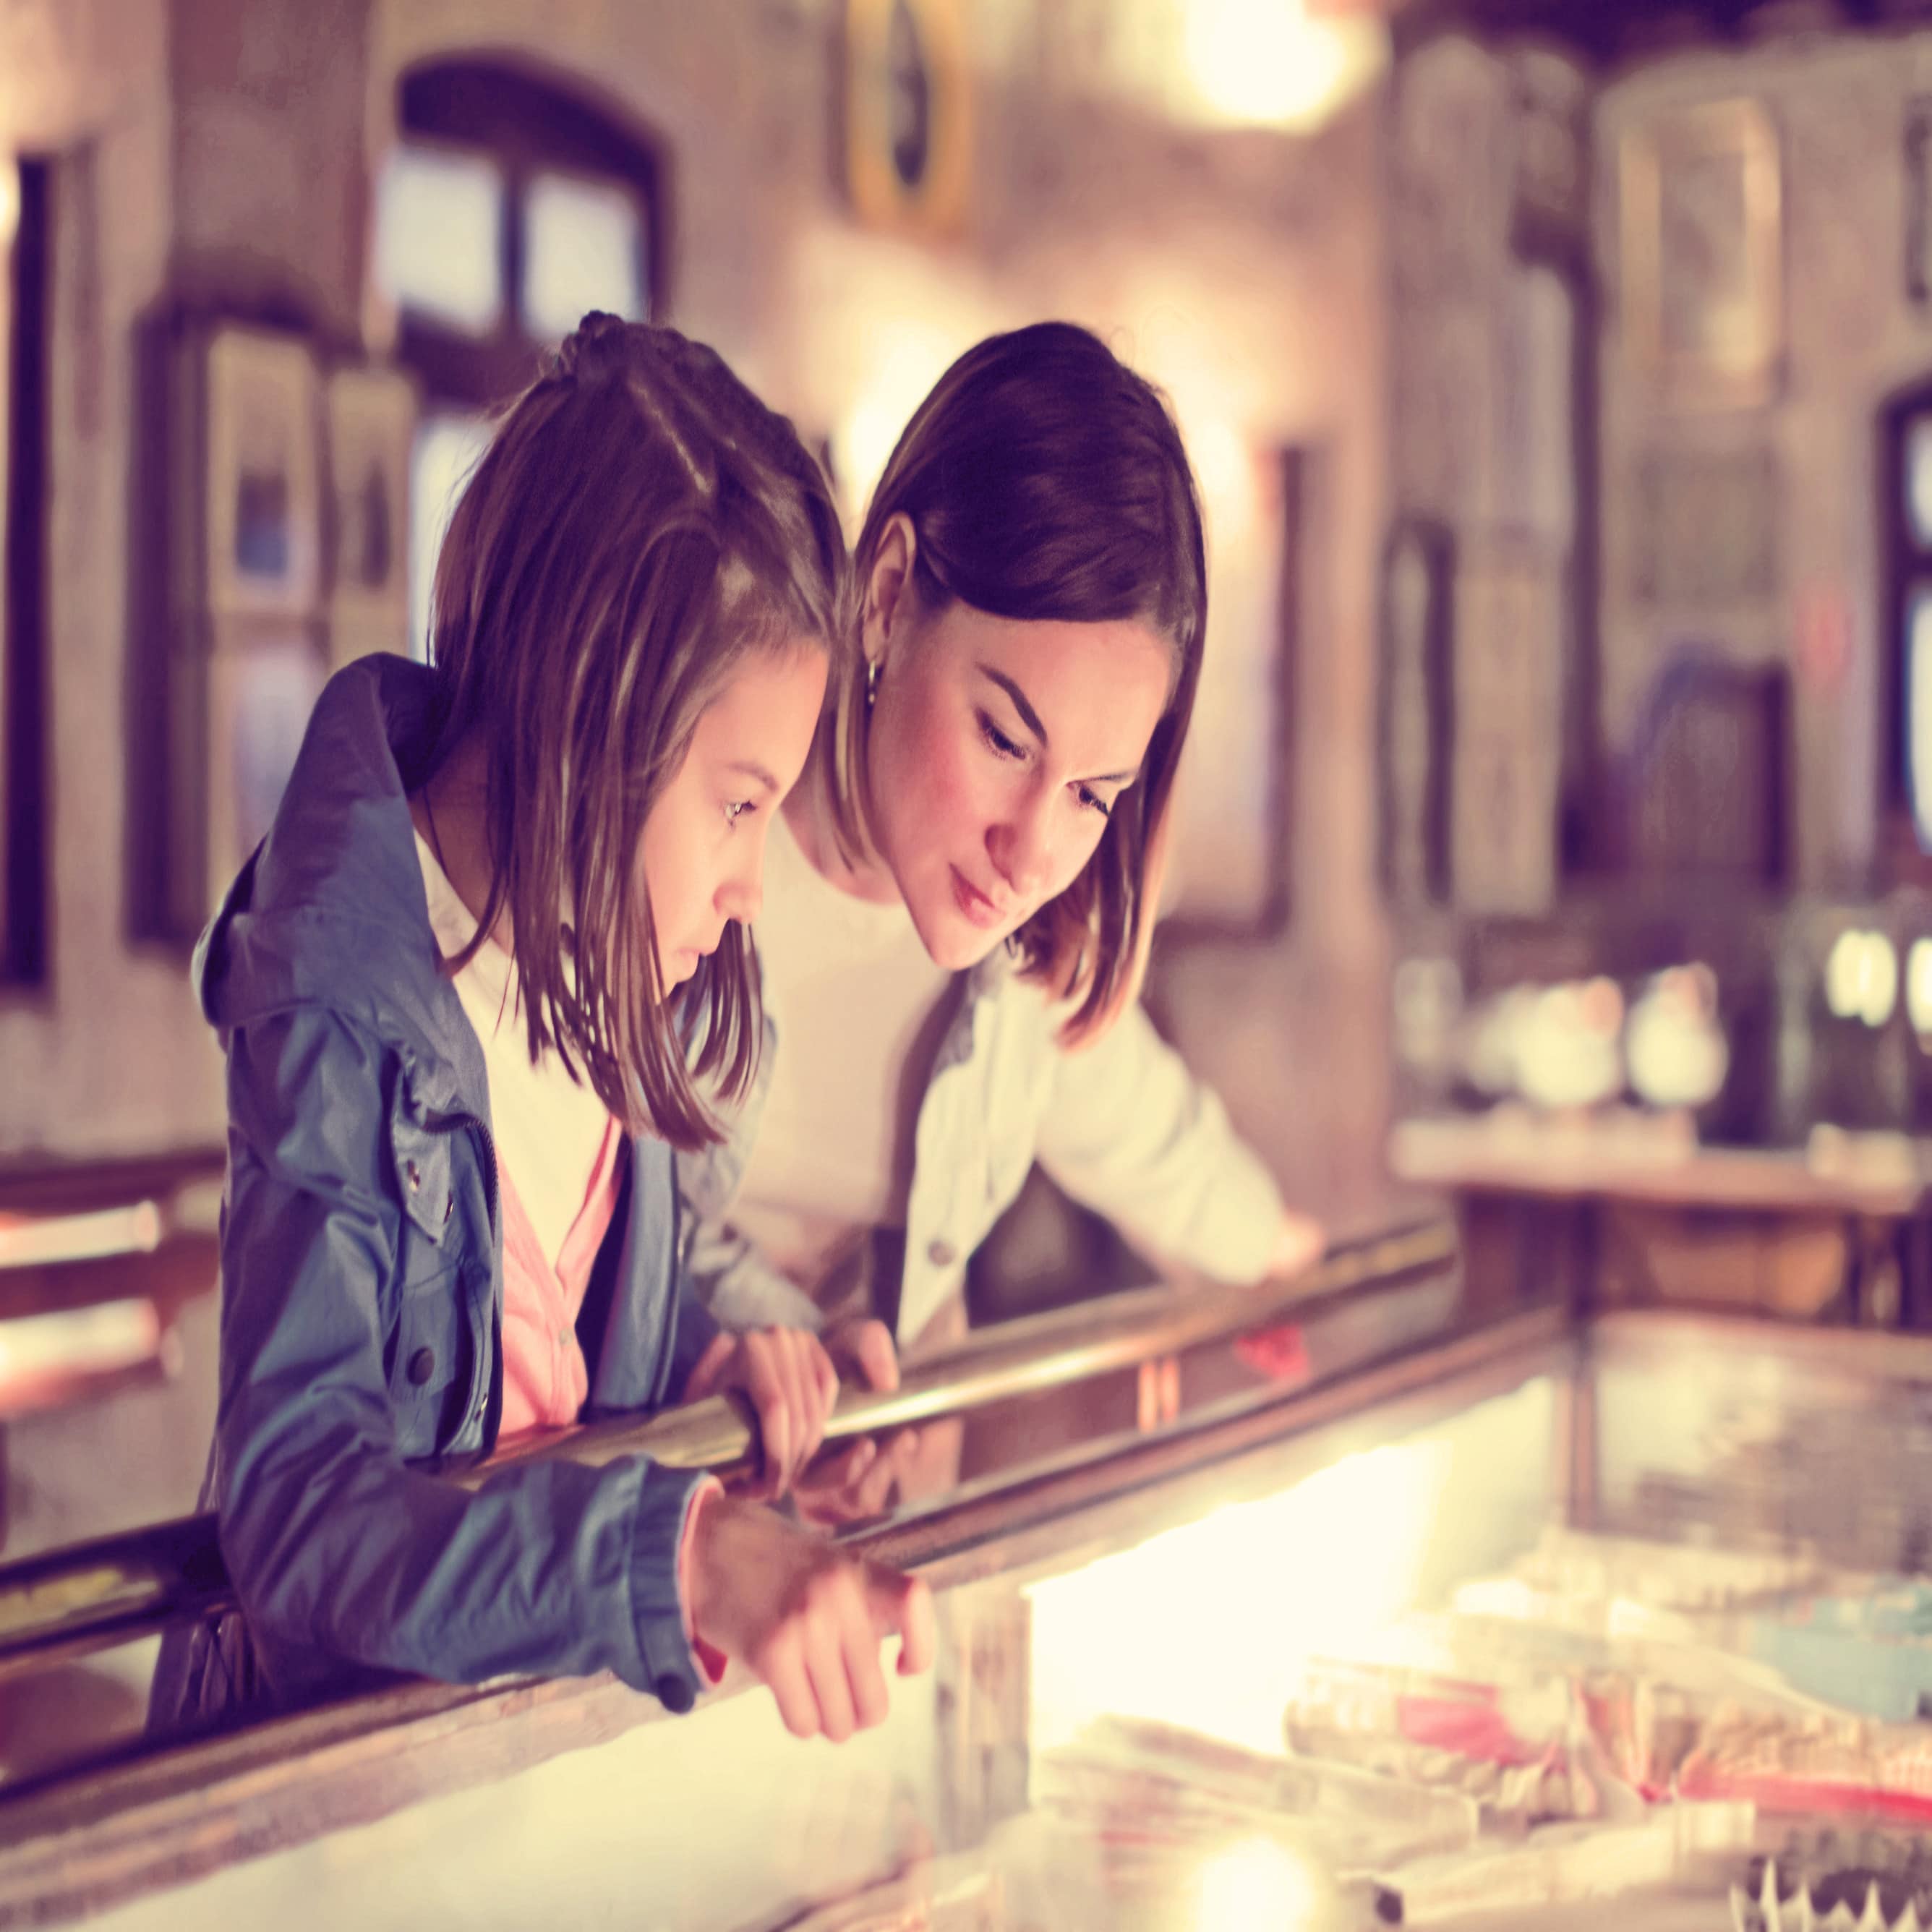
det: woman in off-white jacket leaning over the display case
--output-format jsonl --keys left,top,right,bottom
{"left": 680, "top": 322, "right": 1322, "bottom": 1501}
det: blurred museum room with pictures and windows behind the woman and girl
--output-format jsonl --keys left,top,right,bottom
{"left": 0, "top": 0, "right": 1932, "bottom": 1615}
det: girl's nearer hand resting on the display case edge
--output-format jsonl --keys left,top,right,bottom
{"left": 686, "top": 1493, "right": 937, "bottom": 1743}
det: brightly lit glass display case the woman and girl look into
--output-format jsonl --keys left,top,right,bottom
{"left": 11, "top": 1248, "right": 1932, "bottom": 1932}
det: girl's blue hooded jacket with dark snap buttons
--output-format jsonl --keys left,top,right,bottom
{"left": 150, "top": 657, "right": 717, "bottom": 1729}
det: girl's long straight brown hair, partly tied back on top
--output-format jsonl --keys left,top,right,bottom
{"left": 431, "top": 315, "right": 846, "bottom": 1147}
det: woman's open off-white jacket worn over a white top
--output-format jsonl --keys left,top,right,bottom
{"left": 678, "top": 931, "right": 1283, "bottom": 1346}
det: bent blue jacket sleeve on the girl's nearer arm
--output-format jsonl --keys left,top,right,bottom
{"left": 216, "top": 1009, "right": 714, "bottom": 1708}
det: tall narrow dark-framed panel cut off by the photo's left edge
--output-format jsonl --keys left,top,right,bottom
{"left": 0, "top": 158, "right": 52, "bottom": 987}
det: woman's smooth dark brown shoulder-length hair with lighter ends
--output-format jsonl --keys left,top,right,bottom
{"left": 829, "top": 322, "right": 1208, "bottom": 1046}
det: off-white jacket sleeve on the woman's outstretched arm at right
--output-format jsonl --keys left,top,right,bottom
{"left": 1038, "top": 1001, "right": 1283, "bottom": 1283}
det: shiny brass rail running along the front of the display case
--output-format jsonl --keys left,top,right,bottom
{"left": 0, "top": 1219, "right": 1457, "bottom": 1681}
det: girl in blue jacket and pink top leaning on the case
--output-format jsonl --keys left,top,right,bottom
{"left": 155, "top": 317, "right": 931, "bottom": 1737}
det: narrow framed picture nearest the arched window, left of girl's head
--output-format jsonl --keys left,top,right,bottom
{"left": 327, "top": 367, "right": 417, "bottom": 664}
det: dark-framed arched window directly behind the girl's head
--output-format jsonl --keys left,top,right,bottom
{"left": 375, "top": 60, "right": 669, "bottom": 655}
